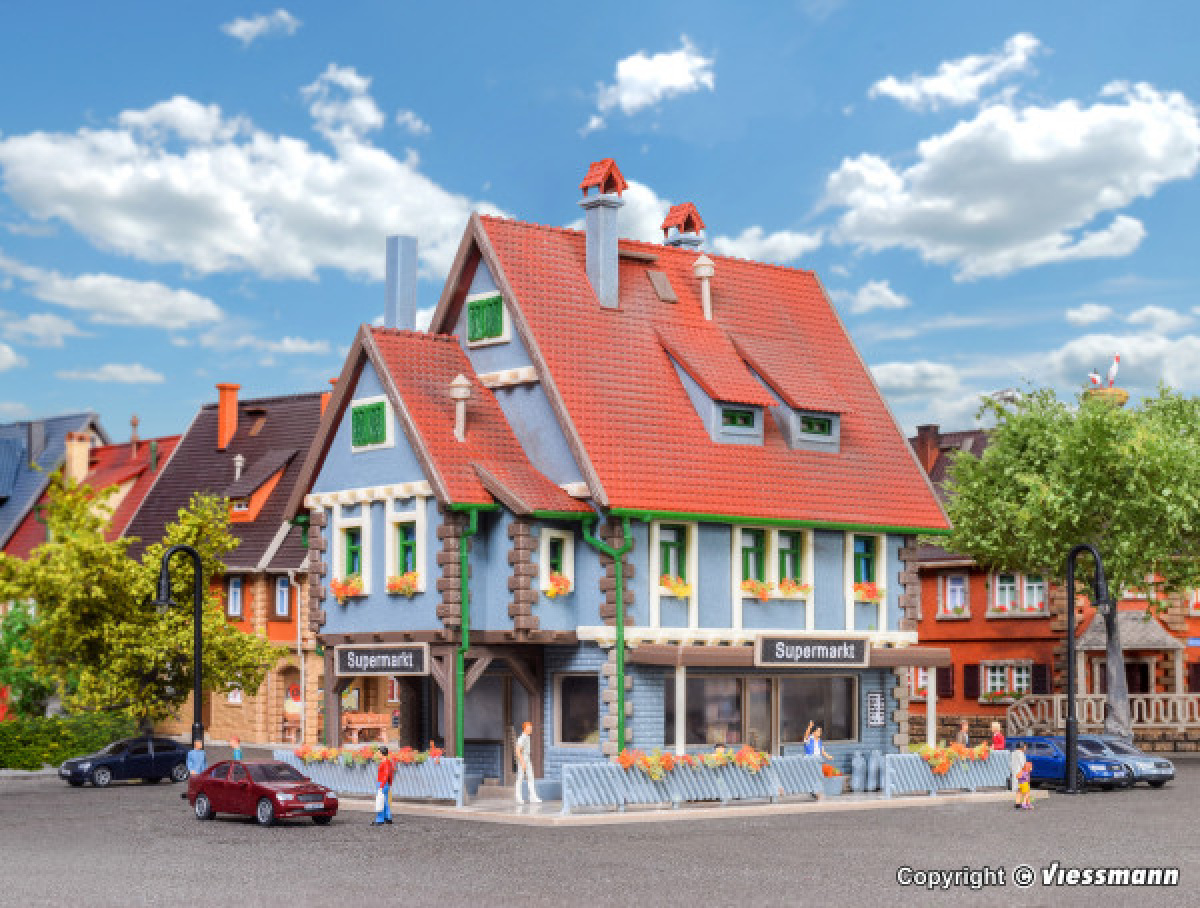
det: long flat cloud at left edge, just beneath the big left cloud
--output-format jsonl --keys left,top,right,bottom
{"left": 0, "top": 253, "right": 222, "bottom": 330}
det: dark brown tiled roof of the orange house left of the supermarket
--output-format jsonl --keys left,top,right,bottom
{"left": 125, "top": 392, "right": 320, "bottom": 572}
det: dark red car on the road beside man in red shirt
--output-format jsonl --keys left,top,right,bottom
{"left": 184, "top": 760, "right": 337, "bottom": 826}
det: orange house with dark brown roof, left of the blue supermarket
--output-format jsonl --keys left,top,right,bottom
{"left": 126, "top": 384, "right": 328, "bottom": 742}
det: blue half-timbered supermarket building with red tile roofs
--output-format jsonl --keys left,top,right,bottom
{"left": 288, "top": 160, "right": 948, "bottom": 781}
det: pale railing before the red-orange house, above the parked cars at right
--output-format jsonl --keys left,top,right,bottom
{"left": 1007, "top": 693, "right": 1200, "bottom": 734}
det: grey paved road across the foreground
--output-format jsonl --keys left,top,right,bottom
{"left": 0, "top": 762, "right": 1200, "bottom": 908}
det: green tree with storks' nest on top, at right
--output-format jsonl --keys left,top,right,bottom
{"left": 947, "top": 387, "right": 1200, "bottom": 738}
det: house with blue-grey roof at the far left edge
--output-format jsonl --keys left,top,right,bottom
{"left": 0, "top": 413, "right": 108, "bottom": 720}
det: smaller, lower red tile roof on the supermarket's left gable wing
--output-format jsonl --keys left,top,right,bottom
{"left": 371, "top": 327, "right": 589, "bottom": 512}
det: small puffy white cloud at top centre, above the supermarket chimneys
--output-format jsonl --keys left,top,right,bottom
{"left": 583, "top": 35, "right": 716, "bottom": 133}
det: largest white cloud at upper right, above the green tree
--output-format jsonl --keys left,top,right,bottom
{"left": 824, "top": 84, "right": 1200, "bottom": 279}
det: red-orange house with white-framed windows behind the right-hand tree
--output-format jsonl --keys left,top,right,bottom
{"left": 910, "top": 426, "right": 1200, "bottom": 738}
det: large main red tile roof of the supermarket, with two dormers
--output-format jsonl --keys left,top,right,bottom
{"left": 468, "top": 217, "right": 946, "bottom": 529}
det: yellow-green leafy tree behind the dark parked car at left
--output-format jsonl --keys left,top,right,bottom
{"left": 0, "top": 475, "right": 281, "bottom": 723}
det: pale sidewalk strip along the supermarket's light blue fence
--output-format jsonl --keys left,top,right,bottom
{"left": 340, "top": 792, "right": 1036, "bottom": 826}
